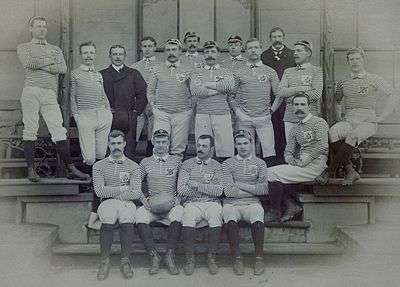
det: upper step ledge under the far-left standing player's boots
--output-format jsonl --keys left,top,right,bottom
{"left": 0, "top": 178, "right": 90, "bottom": 197}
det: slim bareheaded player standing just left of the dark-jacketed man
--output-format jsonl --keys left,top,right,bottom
{"left": 71, "top": 42, "right": 113, "bottom": 166}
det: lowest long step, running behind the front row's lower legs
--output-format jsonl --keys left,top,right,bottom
{"left": 52, "top": 243, "right": 345, "bottom": 255}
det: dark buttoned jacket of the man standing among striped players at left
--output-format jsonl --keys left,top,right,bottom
{"left": 100, "top": 65, "right": 147, "bottom": 132}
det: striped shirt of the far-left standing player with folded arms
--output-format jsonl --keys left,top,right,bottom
{"left": 17, "top": 39, "right": 67, "bottom": 92}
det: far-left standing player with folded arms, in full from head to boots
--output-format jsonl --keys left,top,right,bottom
{"left": 17, "top": 16, "right": 89, "bottom": 182}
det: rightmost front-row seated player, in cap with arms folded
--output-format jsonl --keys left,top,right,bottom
{"left": 222, "top": 130, "right": 268, "bottom": 275}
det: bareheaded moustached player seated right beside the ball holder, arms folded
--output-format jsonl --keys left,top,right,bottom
{"left": 178, "top": 135, "right": 223, "bottom": 275}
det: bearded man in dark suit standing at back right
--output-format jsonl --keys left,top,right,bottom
{"left": 261, "top": 27, "right": 296, "bottom": 164}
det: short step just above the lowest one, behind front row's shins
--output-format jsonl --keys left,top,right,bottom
{"left": 87, "top": 221, "right": 311, "bottom": 243}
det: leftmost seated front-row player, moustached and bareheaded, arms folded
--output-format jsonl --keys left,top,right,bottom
{"left": 93, "top": 130, "right": 143, "bottom": 280}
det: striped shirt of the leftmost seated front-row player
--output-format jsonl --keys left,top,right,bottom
{"left": 93, "top": 157, "right": 143, "bottom": 200}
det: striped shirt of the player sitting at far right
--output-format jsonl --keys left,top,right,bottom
{"left": 335, "top": 73, "right": 394, "bottom": 112}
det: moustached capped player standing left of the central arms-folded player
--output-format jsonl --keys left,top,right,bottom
{"left": 148, "top": 39, "right": 193, "bottom": 157}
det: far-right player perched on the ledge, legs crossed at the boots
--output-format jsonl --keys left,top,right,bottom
{"left": 316, "top": 48, "right": 396, "bottom": 185}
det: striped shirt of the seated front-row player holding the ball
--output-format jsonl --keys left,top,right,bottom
{"left": 140, "top": 154, "right": 181, "bottom": 196}
